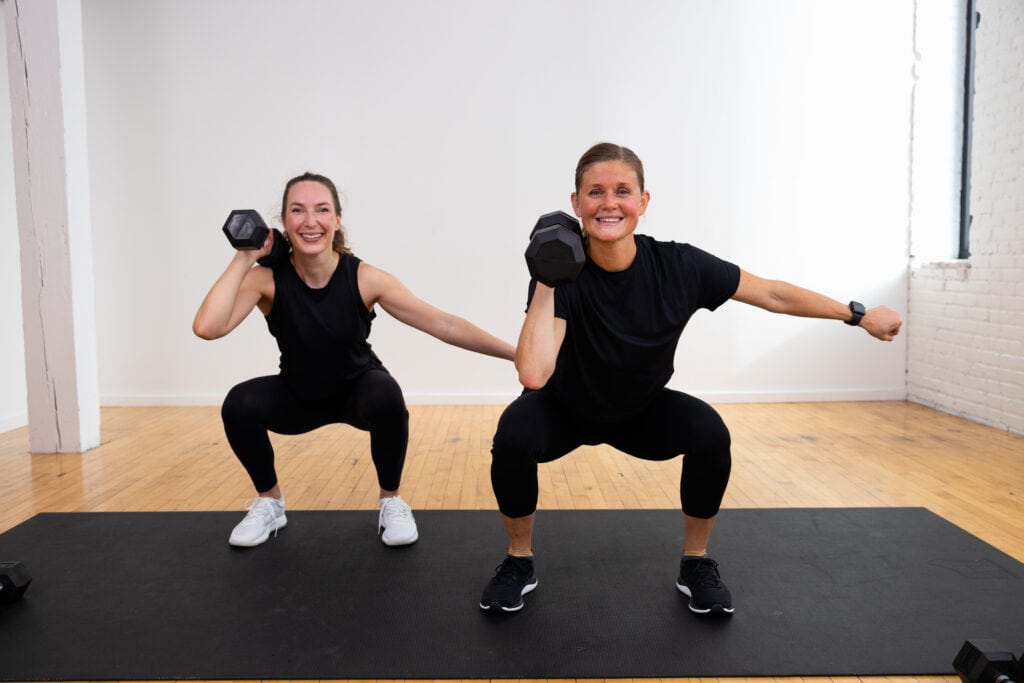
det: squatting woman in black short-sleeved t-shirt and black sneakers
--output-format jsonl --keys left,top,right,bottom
{"left": 480, "top": 143, "right": 901, "bottom": 614}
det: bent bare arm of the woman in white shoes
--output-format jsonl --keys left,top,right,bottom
{"left": 193, "top": 233, "right": 273, "bottom": 339}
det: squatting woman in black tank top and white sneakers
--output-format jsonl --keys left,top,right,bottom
{"left": 193, "top": 173, "right": 515, "bottom": 547}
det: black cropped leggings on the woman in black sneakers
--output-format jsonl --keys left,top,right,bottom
{"left": 490, "top": 389, "right": 732, "bottom": 519}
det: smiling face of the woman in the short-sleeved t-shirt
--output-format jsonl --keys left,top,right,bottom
{"left": 571, "top": 160, "right": 650, "bottom": 243}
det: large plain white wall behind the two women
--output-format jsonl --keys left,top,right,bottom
{"left": 5, "top": 0, "right": 913, "bottom": 421}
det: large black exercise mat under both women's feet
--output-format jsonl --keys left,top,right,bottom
{"left": 0, "top": 508, "right": 1024, "bottom": 681}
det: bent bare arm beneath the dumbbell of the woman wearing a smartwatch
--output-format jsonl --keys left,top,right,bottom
{"left": 515, "top": 283, "right": 565, "bottom": 389}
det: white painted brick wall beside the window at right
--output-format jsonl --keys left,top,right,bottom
{"left": 907, "top": 0, "right": 1024, "bottom": 434}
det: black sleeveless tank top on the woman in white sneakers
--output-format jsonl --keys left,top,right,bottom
{"left": 266, "top": 254, "right": 383, "bottom": 400}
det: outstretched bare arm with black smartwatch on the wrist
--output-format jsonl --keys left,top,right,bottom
{"left": 732, "top": 270, "right": 903, "bottom": 341}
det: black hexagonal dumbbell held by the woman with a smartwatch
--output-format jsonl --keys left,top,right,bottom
{"left": 526, "top": 211, "right": 587, "bottom": 287}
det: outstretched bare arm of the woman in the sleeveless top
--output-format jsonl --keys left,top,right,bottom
{"left": 358, "top": 261, "right": 515, "bottom": 360}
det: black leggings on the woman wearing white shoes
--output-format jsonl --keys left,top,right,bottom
{"left": 220, "top": 370, "right": 409, "bottom": 493}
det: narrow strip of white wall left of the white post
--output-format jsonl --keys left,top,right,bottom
{"left": 0, "top": 14, "right": 29, "bottom": 432}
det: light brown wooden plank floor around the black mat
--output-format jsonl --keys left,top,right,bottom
{"left": 0, "top": 401, "right": 1024, "bottom": 683}
